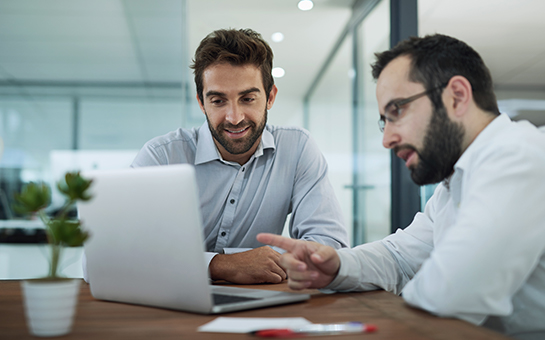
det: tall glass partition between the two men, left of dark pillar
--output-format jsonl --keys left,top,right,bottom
{"left": 305, "top": 1, "right": 391, "bottom": 245}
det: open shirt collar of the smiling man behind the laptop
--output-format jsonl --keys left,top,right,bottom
{"left": 195, "top": 121, "right": 276, "bottom": 165}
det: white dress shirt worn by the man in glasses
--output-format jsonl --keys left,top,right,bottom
{"left": 327, "top": 115, "right": 545, "bottom": 339}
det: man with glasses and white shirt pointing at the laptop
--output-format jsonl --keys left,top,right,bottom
{"left": 258, "top": 35, "right": 545, "bottom": 339}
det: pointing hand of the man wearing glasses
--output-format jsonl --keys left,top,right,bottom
{"left": 257, "top": 233, "right": 341, "bottom": 290}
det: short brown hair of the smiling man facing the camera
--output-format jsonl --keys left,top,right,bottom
{"left": 190, "top": 29, "right": 274, "bottom": 102}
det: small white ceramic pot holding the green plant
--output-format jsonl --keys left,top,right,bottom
{"left": 21, "top": 279, "right": 81, "bottom": 337}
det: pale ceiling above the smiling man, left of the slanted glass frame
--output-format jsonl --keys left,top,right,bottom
{"left": 0, "top": 0, "right": 352, "bottom": 98}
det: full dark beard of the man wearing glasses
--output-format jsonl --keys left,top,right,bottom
{"left": 394, "top": 105, "right": 465, "bottom": 185}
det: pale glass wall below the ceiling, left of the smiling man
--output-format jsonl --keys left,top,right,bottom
{"left": 0, "top": 85, "right": 204, "bottom": 218}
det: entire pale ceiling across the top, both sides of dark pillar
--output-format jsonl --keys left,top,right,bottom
{"left": 0, "top": 0, "right": 545, "bottom": 123}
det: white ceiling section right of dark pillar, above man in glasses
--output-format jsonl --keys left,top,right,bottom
{"left": 419, "top": 0, "right": 545, "bottom": 87}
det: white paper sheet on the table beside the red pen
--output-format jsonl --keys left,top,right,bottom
{"left": 197, "top": 317, "right": 312, "bottom": 333}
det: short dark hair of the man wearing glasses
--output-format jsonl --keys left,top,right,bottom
{"left": 371, "top": 34, "right": 500, "bottom": 115}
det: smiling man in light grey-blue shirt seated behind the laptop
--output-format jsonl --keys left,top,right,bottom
{"left": 132, "top": 29, "right": 348, "bottom": 284}
